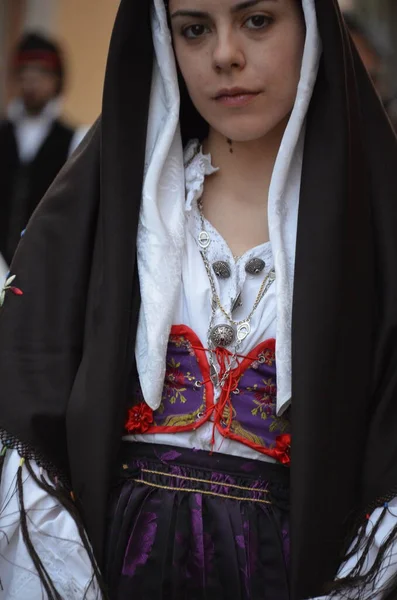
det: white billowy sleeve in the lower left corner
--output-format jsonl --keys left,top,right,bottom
{"left": 0, "top": 450, "right": 101, "bottom": 600}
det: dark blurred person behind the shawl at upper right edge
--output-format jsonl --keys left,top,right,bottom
{"left": 343, "top": 12, "right": 397, "bottom": 129}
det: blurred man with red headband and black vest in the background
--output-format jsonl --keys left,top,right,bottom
{"left": 0, "top": 32, "right": 85, "bottom": 264}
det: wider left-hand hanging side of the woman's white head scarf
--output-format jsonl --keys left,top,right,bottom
{"left": 136, "top": 0, "right": 185, "bottom": 409}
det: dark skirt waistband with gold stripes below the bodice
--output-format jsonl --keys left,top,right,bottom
{"left": 119, "top": 442, "right": 289, "bottom": 510}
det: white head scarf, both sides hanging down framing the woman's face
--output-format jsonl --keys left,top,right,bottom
{"left": 135, "top": 0, "right": 321, "bottom": 414}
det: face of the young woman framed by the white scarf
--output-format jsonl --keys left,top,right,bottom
{"left": 169, "top": 0, "right": 305, "bottom": 142}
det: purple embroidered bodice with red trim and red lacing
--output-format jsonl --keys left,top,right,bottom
{"left": 126, "top": 325, "right": 290, "bottom": 464}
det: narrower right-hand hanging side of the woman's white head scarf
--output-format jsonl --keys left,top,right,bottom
{"left": 268, "top": 0, "right": 322, "bottom": 414}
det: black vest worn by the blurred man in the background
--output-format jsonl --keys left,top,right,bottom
{"left": 0, "top": 120, "right": 74, "bottom": 264}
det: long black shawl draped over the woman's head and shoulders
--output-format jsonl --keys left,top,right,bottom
{"left": 0, "top": 0, "right": 397, "bottom": 600}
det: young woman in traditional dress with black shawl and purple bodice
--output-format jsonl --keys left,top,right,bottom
{"left": 0, "top": 0, "right": 397, "bottom": 600}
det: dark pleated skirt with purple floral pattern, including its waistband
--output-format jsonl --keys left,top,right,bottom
{"left": 105, "top": 443, "right": 290, "bottom": 600}
